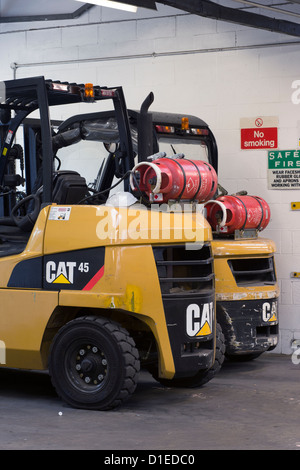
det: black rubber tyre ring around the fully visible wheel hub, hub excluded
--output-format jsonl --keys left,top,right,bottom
{"left": 49, "top": 316, "right": 140, "bottom": 411}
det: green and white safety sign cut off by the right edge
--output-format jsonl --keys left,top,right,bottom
{"left": 268, "top": 150, "right": 300, "bottom": 189}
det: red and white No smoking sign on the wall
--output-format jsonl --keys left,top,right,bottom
{"left": 241, "top": 116, "right": 278, "bottom": 150}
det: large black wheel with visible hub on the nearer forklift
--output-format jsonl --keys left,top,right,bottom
{"left": 49, "top": 316, "right": 140, "bottom": 410}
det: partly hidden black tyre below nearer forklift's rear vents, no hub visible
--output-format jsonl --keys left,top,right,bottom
{"left": 153, "top": 323, "right": 225, "bottom": 388}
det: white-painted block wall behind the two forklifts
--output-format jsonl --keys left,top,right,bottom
{"left": 0, "top": 5, "right": 300, "bottom": 354}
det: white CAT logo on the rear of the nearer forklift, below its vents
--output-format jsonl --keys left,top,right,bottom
{"left": 186, "top": 302, "right": 214, "bottom": 337}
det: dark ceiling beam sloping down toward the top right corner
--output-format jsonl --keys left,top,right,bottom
{"left": 156, "top": 0, "right": 300, "bottom": 37}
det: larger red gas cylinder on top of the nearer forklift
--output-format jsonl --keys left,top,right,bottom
{"left": 130, "top": 157, "right": 218, "bottom": 202}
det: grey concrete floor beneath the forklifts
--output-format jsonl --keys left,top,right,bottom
{"left": 0, "top": 353, "right": 300, "bottom": 455}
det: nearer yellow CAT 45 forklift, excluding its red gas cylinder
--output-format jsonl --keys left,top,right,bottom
{"left": 0, "top": 77, "right": 223, "bottom": 410}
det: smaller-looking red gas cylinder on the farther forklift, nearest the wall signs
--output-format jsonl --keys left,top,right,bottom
{"left": 205, "top": 196, "right": 271, "bottom": 234}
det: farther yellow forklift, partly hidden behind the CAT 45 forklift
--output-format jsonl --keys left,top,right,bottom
{"left": 129, "top": 94, "right": 279, "bottom": 361}
